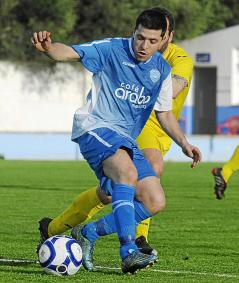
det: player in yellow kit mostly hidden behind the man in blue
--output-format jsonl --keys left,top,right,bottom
{"left": 39, "top": 8, "right": 193, "bottom": 253}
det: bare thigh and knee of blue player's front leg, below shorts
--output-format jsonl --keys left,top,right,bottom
{"left": 102, "top": 149, "right": 138, "bottom": 185}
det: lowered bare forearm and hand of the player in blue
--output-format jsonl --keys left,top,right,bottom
{"left": 155, "top": 111, "right": 202, "bottom": 168}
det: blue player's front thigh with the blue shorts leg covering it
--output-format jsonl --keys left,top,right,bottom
{"left": 78, "top": 128, "right": 137, "bottom": 187}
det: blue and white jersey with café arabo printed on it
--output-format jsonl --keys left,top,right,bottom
{"left": 72, "top": 38, "right": 172, "bottom": 140}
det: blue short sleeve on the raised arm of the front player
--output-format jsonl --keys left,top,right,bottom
{"left": 71, "top": 39, "right": 111, "bottom": 73}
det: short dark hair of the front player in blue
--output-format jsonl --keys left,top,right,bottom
{"left": 135, "top": 7, "right": 167, "bottom": 36}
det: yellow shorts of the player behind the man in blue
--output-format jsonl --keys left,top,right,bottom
{"left": 136, "top": 121, "right": 172, "bottom": 156}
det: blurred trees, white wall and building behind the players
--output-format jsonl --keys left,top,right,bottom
{"left": 0, "top": 0, "right": 239, "bottom": 161}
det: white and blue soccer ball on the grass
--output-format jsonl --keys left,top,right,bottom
{"left": 38, "top": 235, "right": 82, "bottom": 276}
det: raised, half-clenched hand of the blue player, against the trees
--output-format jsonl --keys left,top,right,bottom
{"left": 31, "top": 31, "right": 51, "bottom": 52}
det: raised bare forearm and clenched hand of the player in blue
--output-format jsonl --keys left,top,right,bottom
{"left": 31, "top": 31, "right": 80, "bottom": 62}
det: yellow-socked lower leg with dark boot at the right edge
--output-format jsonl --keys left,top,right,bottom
{"left": 212, "top": 145, "right": 239, "bottom": 199}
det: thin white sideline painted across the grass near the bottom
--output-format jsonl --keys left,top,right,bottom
{"left": 0, "top": 258, "right": 239, "bottom": 278}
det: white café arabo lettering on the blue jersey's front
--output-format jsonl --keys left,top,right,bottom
{"left": 115, "top": 83, "right": 150, "bottom": 108}
